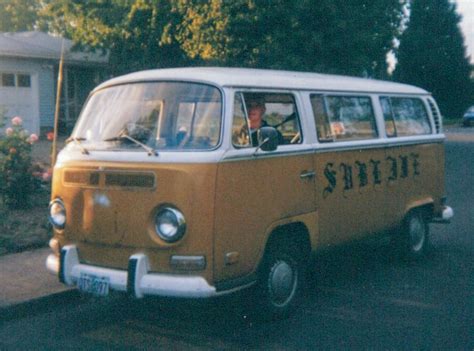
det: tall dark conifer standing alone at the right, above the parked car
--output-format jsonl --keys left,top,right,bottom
{"left": 394, "top": 0, "right": 473, "bottom": 118}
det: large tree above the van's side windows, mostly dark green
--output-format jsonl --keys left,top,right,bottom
{"left": 174, "top": 0, "right": 404, "bottom": 77}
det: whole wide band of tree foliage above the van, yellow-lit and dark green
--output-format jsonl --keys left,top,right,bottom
{"left": 36, "top": 0, "right": 403, "bottom": 77}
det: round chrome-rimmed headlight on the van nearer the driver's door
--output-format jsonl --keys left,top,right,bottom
{"left": 155, "top": 207, "right": 186, "bottom": 243}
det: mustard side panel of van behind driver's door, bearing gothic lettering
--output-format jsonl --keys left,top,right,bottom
{"left": 315, "top": 143, "right": 444, "bottom": 247}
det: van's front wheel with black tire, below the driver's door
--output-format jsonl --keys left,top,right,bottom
{"left": 254, "top": 243, "right": 305, "bottom": 320}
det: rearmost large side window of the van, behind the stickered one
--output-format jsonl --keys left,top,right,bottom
{"left": 380, "top": 97, "right": 431, "bottom": 137}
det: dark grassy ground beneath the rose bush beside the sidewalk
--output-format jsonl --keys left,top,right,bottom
{"left": 0, "top": 189, "right": 52, "bottom": 255}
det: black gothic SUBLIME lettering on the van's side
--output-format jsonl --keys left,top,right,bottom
{"left": 323, "top": 153, "right": 420, "bottom": 199}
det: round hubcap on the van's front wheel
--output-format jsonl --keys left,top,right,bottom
{"left": 268, "top": 261, "right": 297, "bottom": 307}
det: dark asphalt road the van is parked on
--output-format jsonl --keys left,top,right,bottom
{"left": 0, "top": 135, "right": 474, "bottom": 350}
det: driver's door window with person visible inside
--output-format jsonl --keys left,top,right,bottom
{"left": 232, "top": 92, "right": 303, "bottom": 148}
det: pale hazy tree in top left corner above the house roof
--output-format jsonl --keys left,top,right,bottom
{"left": 0, "top": 0, "right": 41, "bottom": 32}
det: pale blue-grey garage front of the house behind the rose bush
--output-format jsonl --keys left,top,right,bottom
{"left": 0, "top": 57, "right": 54, "bottom": 134}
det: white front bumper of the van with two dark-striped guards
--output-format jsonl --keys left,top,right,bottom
{"left": 46, "top": 245, "right": 222, "bottom": 298}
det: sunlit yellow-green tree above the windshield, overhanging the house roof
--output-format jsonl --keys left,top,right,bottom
{"left": 41, "top": 0, "right": 189, "bottom": 74}
